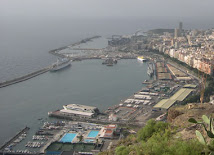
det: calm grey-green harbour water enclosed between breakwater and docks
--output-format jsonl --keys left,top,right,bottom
{"left": 0, "top": 59, "right": 149, "bottom": 150}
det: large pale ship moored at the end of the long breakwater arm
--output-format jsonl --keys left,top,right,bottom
{"left": 50, "top": 58, "right": 71, "bottom": 71}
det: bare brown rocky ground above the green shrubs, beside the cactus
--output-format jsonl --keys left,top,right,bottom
{"left": 167, "top": 103, "right": 214, "bottom": 140}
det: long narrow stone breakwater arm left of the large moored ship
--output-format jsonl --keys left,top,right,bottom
{"left": 0, "top": 66, "right": 51, "bottom": 88}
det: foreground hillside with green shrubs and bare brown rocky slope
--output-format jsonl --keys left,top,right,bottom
{"left": 100, "top": 104, "right": 214, "bottom": 155}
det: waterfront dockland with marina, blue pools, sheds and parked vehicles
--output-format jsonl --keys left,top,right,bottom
{"left": 0, "top": 53, "right": 200, "bottom": 154}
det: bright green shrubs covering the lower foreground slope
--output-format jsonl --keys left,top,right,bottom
{"left": 101, "top": 120, "right": 205, "bottom": 155}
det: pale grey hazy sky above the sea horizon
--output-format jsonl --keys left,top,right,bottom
{"left": 0, "top": 0, "right": 214, "bottom": 17}
